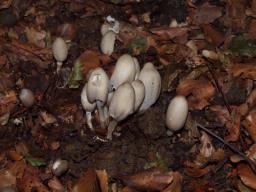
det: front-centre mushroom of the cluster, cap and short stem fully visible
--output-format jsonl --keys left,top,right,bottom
{"left": 107, "top": 83, "right": 135, "bottom": 140}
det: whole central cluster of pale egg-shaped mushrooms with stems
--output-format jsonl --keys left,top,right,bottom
{"left": 81, "top": 54, "right": 161, "bottom": 140}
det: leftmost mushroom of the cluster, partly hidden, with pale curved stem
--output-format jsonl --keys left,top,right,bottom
{"left": 81, "top": 84, "right": 96, "bottom": 131}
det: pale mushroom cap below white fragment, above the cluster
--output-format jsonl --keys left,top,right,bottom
{"left": 100, "top": 31, "right": 116, "bottom": 55}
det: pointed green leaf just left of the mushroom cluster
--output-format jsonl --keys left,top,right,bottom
{"left": 68, "top": 60, "right": 84, "bottom": 89}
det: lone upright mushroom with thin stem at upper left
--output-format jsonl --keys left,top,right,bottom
{"left": 52, "top": 37, "right": 68, "bottom": 73}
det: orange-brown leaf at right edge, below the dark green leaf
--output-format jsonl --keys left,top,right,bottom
{"left": 231, "top": 63, "right": 256, "bottom": 80}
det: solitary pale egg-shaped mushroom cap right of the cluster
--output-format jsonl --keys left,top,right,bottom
{"left": 166, "top": 95, "right": 188, "bottom": 131}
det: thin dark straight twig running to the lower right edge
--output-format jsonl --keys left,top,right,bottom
{"left": 197, "top": 123, "right": 256, "bottom": 173}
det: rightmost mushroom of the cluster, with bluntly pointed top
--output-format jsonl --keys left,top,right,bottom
{"left": 138, "top": 62, "right": 161, "bottom": 113}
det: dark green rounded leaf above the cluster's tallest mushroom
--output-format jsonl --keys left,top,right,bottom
{"left": 127, "top": 36, "right": 147, "bottom": 55}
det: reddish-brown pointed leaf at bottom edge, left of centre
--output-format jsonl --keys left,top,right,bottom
{"left": 72, "top": 169, "right": 100, "bottom": 192}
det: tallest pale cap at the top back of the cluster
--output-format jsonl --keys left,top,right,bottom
{"left": 110, "top": 54, "right": 136, "bottom": 89}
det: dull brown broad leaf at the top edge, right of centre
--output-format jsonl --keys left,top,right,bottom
{"left": 190, "top": 2, "right": 222, "bottom": 24}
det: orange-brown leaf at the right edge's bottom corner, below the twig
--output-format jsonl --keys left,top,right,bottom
{"left": 237, "top": 164, "right": 256, "bottom": 189}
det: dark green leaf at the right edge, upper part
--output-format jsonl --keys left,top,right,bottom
{"left": 228, "top": 36, "right": 256, "bottom": 57}
